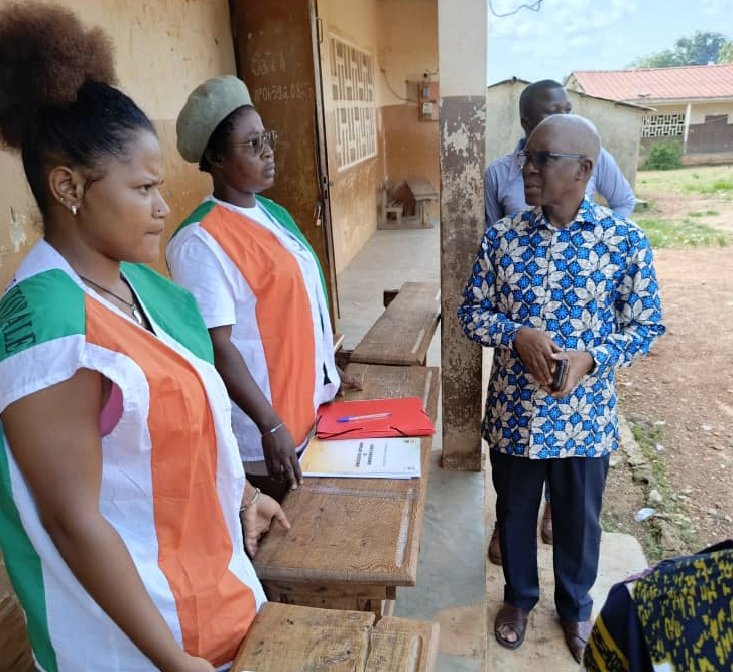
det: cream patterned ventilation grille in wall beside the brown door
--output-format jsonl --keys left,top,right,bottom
{"left": 329, "top": 36, "right": 377, "bottom": 170}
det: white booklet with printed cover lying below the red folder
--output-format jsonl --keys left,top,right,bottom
{"left": 300, "top": 436, "right": 420, "bottom": 479}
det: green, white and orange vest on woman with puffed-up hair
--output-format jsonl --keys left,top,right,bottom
{"left": 0, "top": 240, "right": 265, "bottom": 672}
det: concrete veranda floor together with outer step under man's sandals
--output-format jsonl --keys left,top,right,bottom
{"left": 338, "top": 227, "right": 646, "bottom": 672}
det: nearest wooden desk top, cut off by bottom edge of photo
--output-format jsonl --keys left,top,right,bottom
{"left": 231, "top": 602, "right": 439, "bottom": 672}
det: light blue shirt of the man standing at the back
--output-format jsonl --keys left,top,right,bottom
{"left": 484, "top": 138, "right": 636, "bottom": 226}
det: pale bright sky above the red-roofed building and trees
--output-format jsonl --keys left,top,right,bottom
{"left": 487, "top": 0, "right": 733, "bottom": 84}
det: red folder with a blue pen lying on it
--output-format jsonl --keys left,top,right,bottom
{"left": 316, "top": 397, "right": 435, "bottom": 439}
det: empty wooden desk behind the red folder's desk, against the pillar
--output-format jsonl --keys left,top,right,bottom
{"left": 350, "top": 282, "right": 440, "bottom": 366}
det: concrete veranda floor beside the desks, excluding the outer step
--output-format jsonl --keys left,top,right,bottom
{"left": 338, "top": 227, "right": 486, "bottom": 672}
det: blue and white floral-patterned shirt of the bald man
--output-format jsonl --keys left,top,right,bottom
{"left": 458, "top": 198, "right": 664, "bottom": 459}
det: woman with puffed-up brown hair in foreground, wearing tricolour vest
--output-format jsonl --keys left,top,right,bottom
{"left": 0, "top": 2, "right": 287, "bottom": 672}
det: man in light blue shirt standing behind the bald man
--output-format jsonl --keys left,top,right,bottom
{"left": 484, "top": 79, "right": 636, "bottom": 226}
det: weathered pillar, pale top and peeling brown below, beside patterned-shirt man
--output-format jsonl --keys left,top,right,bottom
{"left": 438, "top": 0, "right": 486, "bottom": 469}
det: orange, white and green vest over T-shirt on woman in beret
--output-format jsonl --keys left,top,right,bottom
{"left": 166, "top": 196, "right": 340, "bottom": 461}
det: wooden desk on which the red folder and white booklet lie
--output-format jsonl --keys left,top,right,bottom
{"left": 254, "top": 364, "right": 440, "bottom": 613}
